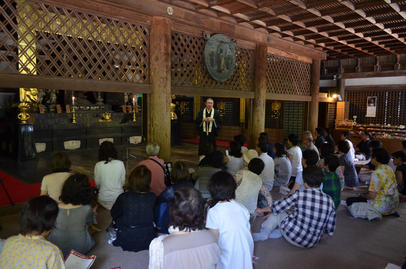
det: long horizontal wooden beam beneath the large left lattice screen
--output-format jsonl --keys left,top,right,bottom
{"left": 0, "top": 74, "right": 151, "bottom": 93}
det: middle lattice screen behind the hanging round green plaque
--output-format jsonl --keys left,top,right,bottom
{"left": 171, "top": 32, "right": 254, "bottom": 91}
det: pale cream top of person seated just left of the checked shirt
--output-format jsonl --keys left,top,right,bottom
{"left": 235, "top": 169, "right": 262, "bottom": 214}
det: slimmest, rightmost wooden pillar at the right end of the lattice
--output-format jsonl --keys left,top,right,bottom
{"left": 309, "top": 60, "right": 320, "bottom": 133}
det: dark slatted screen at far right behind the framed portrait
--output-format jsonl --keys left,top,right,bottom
{"left": 345, "top": 90, "right": 406, "bottom": 125}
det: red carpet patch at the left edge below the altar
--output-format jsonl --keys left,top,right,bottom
{"left": 0, "top": 170, "right": 41, "bottom": 206}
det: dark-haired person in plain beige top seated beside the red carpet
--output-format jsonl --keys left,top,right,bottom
{"left": 41, "top": 152, "right": 72, "bottom": 203}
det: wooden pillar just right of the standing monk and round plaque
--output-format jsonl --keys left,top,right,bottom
{"left": 249, "top": 44, "right": 268, "bottom": 148}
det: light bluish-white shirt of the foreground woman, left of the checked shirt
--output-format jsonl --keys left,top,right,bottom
{"left": 206, "top": 200, "right": 254, "bottom": 269}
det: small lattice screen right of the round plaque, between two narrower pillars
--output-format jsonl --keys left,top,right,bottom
{"left": 266, "top": 54, "right": 311, "bottom": 95}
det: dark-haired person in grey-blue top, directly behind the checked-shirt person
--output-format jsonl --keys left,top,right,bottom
{"left": 273, "top": 143, "right": 292, "bottom": 187}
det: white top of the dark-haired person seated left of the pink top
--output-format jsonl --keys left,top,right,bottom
{"left": 94, "top": 160, "right": 125, "bottom": 210}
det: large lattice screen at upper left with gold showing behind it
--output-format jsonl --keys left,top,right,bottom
{"left": 0, "top": 0, "right": 149, "bottom": 83}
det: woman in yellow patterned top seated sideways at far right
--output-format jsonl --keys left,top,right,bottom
{"left": 347, "top": 148, "right": 399, "bottom": 218}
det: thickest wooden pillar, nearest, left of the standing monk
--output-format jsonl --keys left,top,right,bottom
{"left": 148, "top": 17, "right": 171, "bottom": 161}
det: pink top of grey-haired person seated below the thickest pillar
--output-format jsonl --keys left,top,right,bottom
{"left": 137, "top": 156, "right": 166, "bottom": 196}
